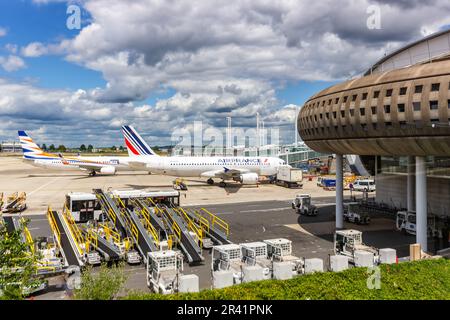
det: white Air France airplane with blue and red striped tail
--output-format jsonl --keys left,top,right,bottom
{"left": 122, "top": 126, "right": 285, "bottom": 187}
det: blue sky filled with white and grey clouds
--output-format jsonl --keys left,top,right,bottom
{"left": 0, "top": 0, "right": 450, "bottom": 146}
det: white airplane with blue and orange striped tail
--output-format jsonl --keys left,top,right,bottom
{"left": 18, "top": 131, "right": 139, "bottom": 176}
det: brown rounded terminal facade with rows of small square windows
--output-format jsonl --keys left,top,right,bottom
{"left": 298, "top": 58, "right": 450, "bottom": 156}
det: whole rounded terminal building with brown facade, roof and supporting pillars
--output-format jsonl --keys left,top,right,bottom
{"left": 297, "top": 30, "right": 450, "bottom": 251}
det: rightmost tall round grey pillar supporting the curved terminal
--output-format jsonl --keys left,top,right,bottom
{"left": 416, "top": 157, "right": 428, "bottom": 251}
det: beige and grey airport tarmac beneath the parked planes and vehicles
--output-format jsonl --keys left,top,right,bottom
{"left": 0, "top": 157, "right": 422, "bottom": 299}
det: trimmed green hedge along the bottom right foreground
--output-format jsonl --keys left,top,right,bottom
{"left": 125, "top": 259, "right": 450, "bottom": 300}
